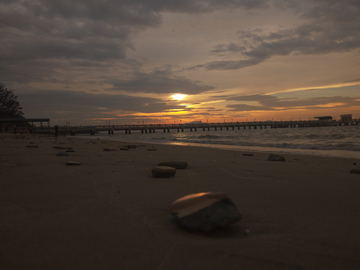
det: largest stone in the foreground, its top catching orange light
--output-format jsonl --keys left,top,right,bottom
{"left": 170, "top": 192, "right": 242, "bottom": 232}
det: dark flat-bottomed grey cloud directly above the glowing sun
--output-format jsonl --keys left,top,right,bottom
{"left": 107, "top": 68, "right": 215, "bottom": 94}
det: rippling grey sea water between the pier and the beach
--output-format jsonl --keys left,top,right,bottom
{"left": 79, "top": 126, "right": 360, "bottom": 159}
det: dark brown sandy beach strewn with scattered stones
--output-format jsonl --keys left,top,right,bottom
{"left": 0, "top": 134, "right": 360, "bottom": 269}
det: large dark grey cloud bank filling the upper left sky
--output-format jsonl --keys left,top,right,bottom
{"left": 0, "top": 0, "right": 263, "bottom": 60}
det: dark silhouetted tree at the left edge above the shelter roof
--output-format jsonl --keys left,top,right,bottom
{"left": 0, "top": 82, "right": 24, "bottom": 118}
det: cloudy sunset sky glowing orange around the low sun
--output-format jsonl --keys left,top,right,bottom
{"left": 0, "top": 0, "right": 360, "bottom": 125}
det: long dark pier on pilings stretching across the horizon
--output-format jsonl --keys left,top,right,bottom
{"left": 31, "top": 119, "right": 360, "bottom": 135}
